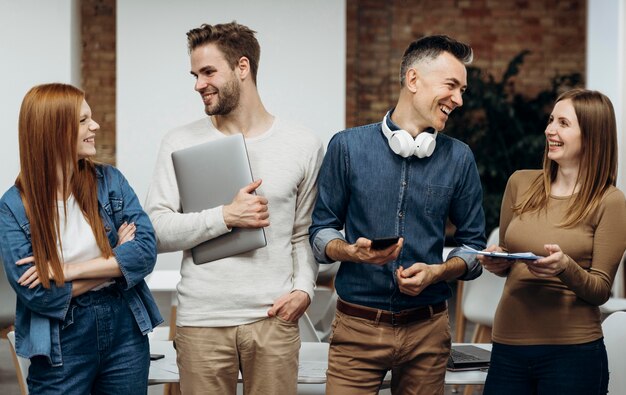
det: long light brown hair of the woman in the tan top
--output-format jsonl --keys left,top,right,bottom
{"left": 513, "top": 89, "right": 618, "bottom": 227}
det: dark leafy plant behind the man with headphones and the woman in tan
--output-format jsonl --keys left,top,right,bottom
{"left": 445, "top": 50, "right": 582, "bottom": 235}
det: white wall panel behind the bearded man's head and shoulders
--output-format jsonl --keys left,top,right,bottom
{"left": 117, "top": 0, "right": 346, "bottom": 268}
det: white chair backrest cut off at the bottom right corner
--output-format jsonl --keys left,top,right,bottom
{"left": 602, "top": 311, "right": 626, "bottom": 394}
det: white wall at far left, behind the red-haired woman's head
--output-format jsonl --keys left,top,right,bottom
{"left": 0, "top": 0, "right": 80, "bottom": 194}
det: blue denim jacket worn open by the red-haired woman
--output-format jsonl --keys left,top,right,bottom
{"left": 0, "top": 165, "right": 163, "bottom": 366}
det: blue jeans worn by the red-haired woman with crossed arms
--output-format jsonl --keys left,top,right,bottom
{"left": 28, "top": 286, "right": 150, "bottom": 395}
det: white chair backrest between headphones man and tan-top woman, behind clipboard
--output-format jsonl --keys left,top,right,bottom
{"left": 462, "top": 228, "right": 506, "bottom": 327}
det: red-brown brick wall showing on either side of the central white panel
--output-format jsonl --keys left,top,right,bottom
{"left": 81, "top": 0, "right": 587, "bottom": 158}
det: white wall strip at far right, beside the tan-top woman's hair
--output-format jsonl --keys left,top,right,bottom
{"left": 587, "top": 0, "right": 626, "bottom": 191}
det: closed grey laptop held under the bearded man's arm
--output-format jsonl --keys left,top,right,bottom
{"left": 172, "top": 134, "right": 267, "bottom": 265}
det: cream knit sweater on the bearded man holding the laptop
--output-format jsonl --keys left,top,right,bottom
{"left": 145, "top": 117, "right": 323, "bottom": 327}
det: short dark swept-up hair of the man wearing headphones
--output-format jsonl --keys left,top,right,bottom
{"left": 400, "top": 35, "right": 474, "bottom": 86}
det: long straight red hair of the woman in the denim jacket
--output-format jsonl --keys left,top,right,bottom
{"left": 16, "top": 84, "right": 113, "bottom": 288}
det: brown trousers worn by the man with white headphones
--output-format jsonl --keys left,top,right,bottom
{"left": 326, "top": 304, "right": 451, "bottom": 395}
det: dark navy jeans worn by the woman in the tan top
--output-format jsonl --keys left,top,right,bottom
{"left": 483, "top": 339, "right": 609, "bottom": 395}
